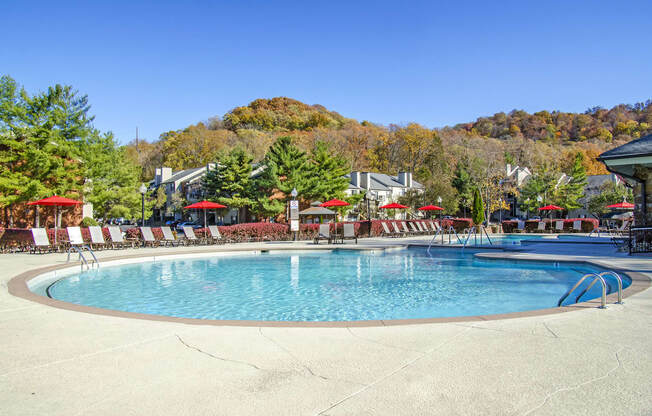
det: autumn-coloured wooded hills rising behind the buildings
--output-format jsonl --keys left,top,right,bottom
{"left": 127, "top": 97, "right": 652, "bottom": 184}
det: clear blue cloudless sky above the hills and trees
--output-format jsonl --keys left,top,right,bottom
{"left": 0, "top": 0, "right": 652, "bottom": 143}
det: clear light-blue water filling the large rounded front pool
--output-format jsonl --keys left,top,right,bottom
{"left": 33, "top": 248, "right": 629, "bottom": 321}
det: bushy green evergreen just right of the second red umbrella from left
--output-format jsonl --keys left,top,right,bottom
{"left": 202, "top": 148, "right": 253, "bottom": 221}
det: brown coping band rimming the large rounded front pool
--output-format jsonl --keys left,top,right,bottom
{"left": 7, "top": 244, "right": 652, "bottom": 328}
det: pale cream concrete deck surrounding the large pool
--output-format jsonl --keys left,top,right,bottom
{"left": 0, "top": 237, "right": 652, "bottom": 415}
